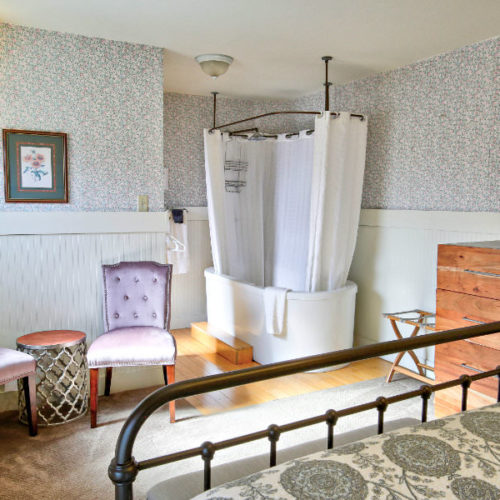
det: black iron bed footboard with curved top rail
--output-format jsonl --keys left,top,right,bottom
{"left": 108, "top": 321, "right": 500, "bottom": 500}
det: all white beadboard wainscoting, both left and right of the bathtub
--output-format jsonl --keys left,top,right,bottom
{"left": 0, "top": 207, "right": 500, "bottom": 411}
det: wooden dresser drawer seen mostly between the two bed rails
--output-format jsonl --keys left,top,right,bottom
{"left": 434, "top": 340, "right": 500, "bottom": 397}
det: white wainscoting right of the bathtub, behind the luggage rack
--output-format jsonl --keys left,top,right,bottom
{"left": 349, "top": 210, "right": 500, "bottom": 369}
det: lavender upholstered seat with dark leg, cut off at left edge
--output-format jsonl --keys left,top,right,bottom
{"left": 0, "top": 347, "right": 38, "bottom": 436}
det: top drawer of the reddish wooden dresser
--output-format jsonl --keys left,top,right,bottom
{"left": 437, "top": 245, "right": 500, "bottom": 299}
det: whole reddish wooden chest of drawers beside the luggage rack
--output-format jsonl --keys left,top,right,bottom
{"left": 435, "top": 241, "right": 500, "bottom": 413}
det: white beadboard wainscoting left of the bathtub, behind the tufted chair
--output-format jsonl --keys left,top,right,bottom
{"left": 0, "top": 208, "right": 212, "bottom": 411}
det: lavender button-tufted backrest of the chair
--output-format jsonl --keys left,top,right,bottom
{"left": 102, "top": 261, "right": 172, "bottom": 331}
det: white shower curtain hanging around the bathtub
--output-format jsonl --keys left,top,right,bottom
{"left": 204, "top": 113, "right": 366, "bottom": 291}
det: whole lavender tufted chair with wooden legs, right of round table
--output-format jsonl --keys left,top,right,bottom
{"left": 87, "top": 262, "right": 177, "bottom": 427}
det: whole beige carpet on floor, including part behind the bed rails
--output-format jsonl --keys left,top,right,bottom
{"left": 0, "top": 378, "right": 430, "bottom": 500}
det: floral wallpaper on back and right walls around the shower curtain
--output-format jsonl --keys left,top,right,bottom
{"left": 164, "top": 38, "right": 500, "bottom": 211}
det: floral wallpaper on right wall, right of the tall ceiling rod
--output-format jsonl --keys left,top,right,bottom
{"left": 333, "top": 38, "right": 500, "bottom": 212}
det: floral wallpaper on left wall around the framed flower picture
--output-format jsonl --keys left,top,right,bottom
{"left": 0, "top": 24, "right": 164, "bottom": 211}
